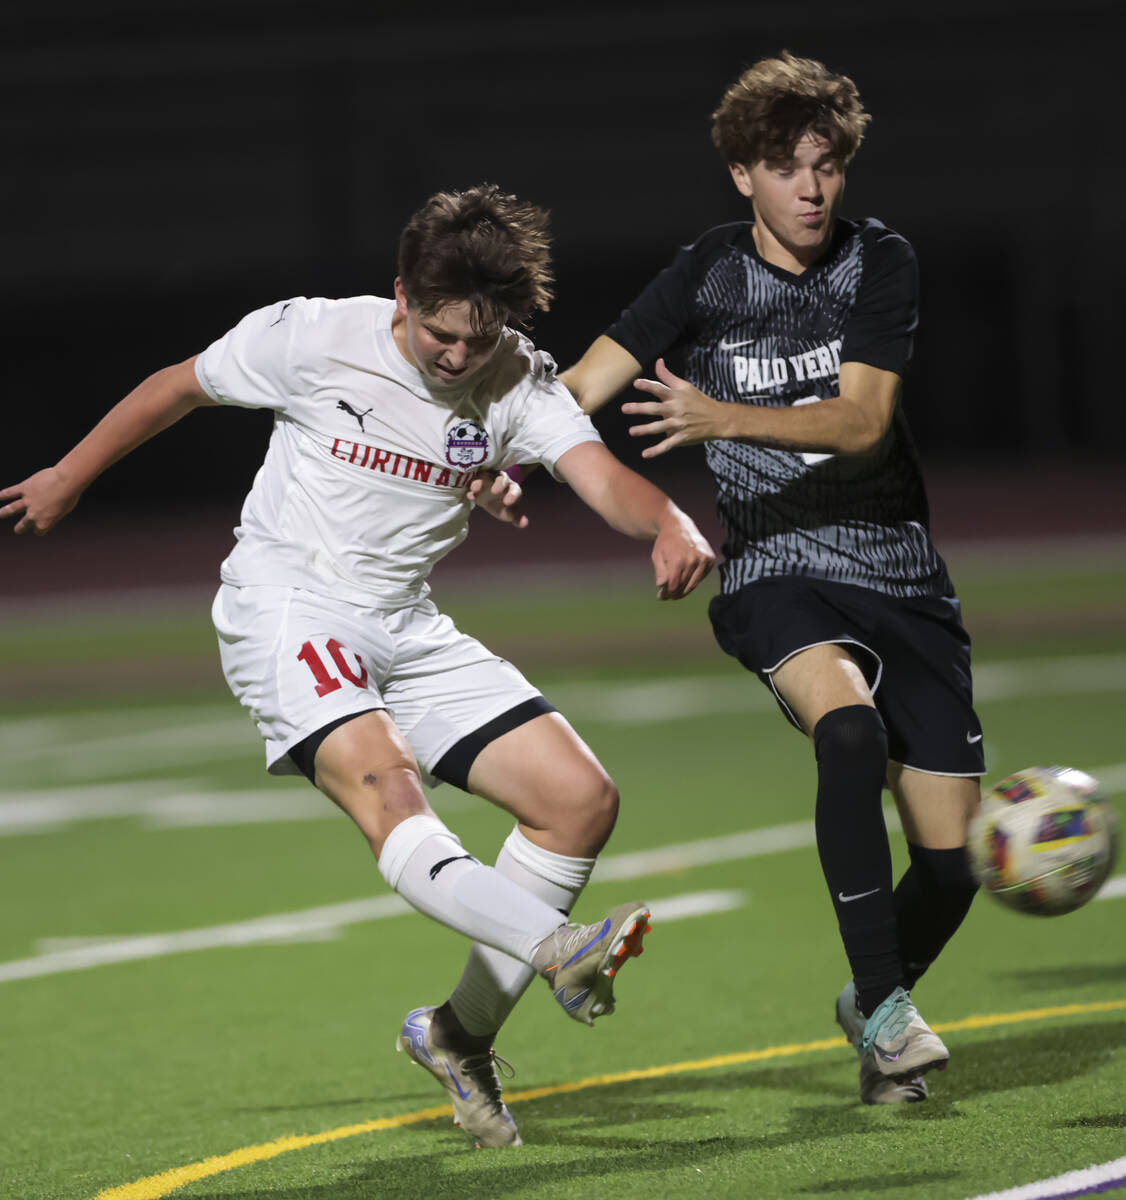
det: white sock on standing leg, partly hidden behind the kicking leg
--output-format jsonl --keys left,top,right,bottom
{"left": 450, "top": 828, "right": 594, "bottom": 1037}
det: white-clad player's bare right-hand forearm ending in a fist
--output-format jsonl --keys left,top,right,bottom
{"left": 556, "top": 442, "right": 715, "bottom": 600}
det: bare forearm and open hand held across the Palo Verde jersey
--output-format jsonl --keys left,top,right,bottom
{"left": 622, "top": 359, "right": 900, "bottom": 458}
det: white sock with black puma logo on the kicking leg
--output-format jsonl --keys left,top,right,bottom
{"left": 379, "top": 814, "right": 563, "bottom": 962}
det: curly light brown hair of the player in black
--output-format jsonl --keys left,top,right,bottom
{"left": 712, "top": 50, "right": 872, "bottom": 167}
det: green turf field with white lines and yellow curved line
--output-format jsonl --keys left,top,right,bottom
{"left": 0, "top": 559, "right": 1126, "bottom": 1200}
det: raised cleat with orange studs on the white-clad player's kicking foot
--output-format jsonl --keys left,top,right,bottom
{"left": 532, "top": 904, "right": 649, "bottom": 1025}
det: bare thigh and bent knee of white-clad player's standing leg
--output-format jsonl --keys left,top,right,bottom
{"left": 468, "top": 713, "right": 618, "bottom": 858}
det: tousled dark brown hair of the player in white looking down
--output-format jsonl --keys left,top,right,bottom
{"left": 399, "top": 184, "right": 555, "bottom": 332}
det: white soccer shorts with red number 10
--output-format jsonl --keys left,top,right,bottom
{"left": 211, "top": 583, "right": 539, "bottom": 784}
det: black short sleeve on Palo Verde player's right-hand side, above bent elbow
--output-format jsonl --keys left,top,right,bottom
{"left": 840, "top": 227, "right": 918, "bottom": 376}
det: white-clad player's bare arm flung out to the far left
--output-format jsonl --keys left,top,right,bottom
{"left": 0, "top": 358, "right": 214, "bottom": 534}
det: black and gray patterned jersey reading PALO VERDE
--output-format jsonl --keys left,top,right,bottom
{"left": 606, "top": 220, "right": 953, "bottom": 596}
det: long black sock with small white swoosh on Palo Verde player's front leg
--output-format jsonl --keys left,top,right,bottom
{"left": 813, "top": 704, "right": 904, "bottom": 1016}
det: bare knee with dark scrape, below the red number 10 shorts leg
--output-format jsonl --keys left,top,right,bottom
{"left": 315, "top": 710, "right": 432, "bottom": 853}
